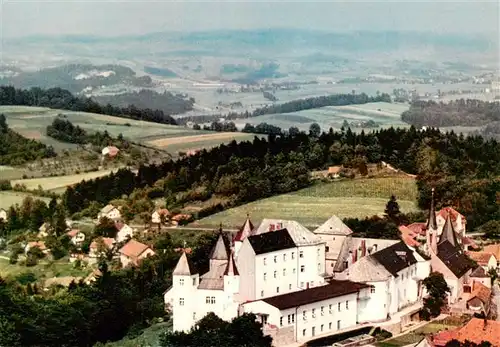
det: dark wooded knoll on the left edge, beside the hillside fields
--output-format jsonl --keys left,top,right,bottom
{"left": 0, "top": 114, "right": 56, "bottom": 165}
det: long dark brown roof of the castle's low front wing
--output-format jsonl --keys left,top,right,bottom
{"left": 262, "top": 280, "right": 370, "bottom": 310}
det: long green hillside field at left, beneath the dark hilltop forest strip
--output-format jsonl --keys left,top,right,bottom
{"left": 0, "top": 106, "right": 262, "bottom": 153}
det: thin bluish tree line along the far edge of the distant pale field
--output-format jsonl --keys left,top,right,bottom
{"left": 179, "top": 93, "right": 391, "bottom": 124}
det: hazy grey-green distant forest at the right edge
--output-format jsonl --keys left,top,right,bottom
{"left": 401, "top": 99, "right": 500, "bottom": 128}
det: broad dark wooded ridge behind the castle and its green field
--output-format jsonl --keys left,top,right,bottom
{"left": 63, "top": 127, "right": 500, "bottom": 234}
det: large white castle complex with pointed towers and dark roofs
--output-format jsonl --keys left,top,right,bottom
{"left": 165, "top": 217, "right": 430, "bottom": 346}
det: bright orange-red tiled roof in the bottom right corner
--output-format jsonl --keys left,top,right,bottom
{"left": 433, "top": 318, "right": 500, "bottom": 346}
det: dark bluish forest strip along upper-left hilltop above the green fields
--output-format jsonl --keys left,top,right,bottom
{"left": 0, "top": 86, "right": 177, "bottom": 125}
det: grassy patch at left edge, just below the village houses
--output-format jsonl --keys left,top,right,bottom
{"left": 0, "top": 253, "right": 91, "bottom": 280}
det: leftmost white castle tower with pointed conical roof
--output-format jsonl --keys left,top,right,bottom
{"left": 169, "top": 250, "right": 200, "bottom": 332}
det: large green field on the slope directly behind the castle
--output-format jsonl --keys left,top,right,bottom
{"left": 193, "top": 177, "right": 418, "bottom": 228}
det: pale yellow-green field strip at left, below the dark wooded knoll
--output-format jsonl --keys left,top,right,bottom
{"left": 11, "top": 169, "right": 116, "bottom": 191}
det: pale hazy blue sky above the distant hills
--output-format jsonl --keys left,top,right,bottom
{"left": 0, "top": 0, "right": 500, "bottom": 38}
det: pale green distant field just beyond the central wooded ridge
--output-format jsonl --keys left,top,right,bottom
{"left": 235, "top": 102, "right": 408, "bottom": 131}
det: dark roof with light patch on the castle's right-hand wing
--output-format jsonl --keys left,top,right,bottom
{"left": 372, "top": 241, "right": 417, "bottom": 277}
